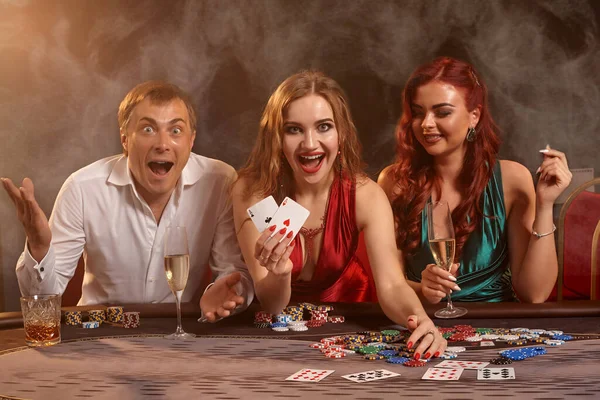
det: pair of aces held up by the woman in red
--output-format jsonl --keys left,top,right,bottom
{"left": 246, "top": 196, "right": 310, "bottom": 240}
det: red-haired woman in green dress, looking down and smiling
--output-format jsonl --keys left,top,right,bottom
{"left": 378, "top": 57, "right": 572, "bottom": 303}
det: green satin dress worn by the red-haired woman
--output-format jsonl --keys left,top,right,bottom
{"left": 406, "top": 162, "right": 517, "bottom": 302}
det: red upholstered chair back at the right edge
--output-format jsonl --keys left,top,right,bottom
{"left": 557, "top": 178, "right": 600, "bottom": 300}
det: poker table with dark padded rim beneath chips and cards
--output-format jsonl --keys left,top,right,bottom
{"left": 0, "top": 301, "right": 600, "bottom": 400}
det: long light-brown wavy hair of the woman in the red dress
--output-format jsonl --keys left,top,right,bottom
{"left": 238, "top": 71, "right": 364, "bottom": 203}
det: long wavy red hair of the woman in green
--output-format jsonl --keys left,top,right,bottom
{"left": 391, "top": 57, "right": 500, "bottom": 260}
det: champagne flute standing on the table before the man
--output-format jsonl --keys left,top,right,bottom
{"left": 165, "top": 226, "right": 196, "bottom": 340}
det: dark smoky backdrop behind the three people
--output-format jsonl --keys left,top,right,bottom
{"left": 0, "top": 0, "right": 600, "bottom": 311}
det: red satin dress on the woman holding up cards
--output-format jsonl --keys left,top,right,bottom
{"left": 290, "top": 179, "right": 376, "bottom": 303}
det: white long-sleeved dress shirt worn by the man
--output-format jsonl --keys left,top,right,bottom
{"left": 16, "top": 153, "right": 254, "bottom": 305}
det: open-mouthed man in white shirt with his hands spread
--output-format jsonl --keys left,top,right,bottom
{"left": 2, "top": 81, "right": 254, "bottom": 321}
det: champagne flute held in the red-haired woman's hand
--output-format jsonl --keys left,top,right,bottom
{"left": 426, "top": 201, "right": 467, "bottom": 318}
